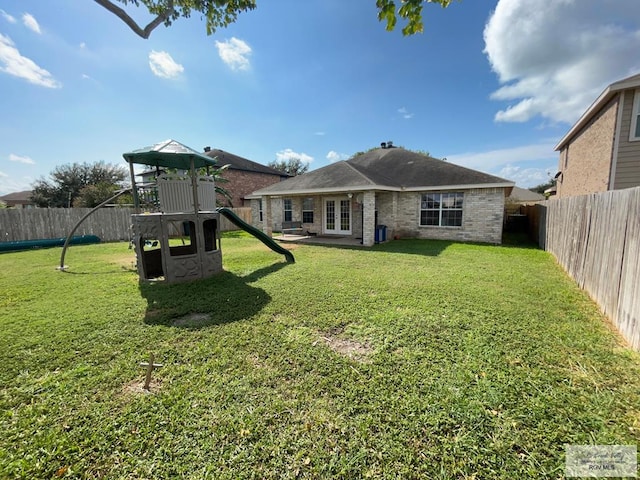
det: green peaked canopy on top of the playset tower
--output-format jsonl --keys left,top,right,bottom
{"left": 122, "top": 140, "right": 216, "bottom": 170}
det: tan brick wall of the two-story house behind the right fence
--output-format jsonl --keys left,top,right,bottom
{"left": 557, "top": 95, "right": 619, "bottom": 197}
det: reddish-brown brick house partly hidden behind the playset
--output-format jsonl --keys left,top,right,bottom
{"left": 204, "top": 147, "right": 291, "bottom": 207}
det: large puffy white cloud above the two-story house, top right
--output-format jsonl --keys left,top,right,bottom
{"left": 484, "top": 0, "right": 640, "bottom": 123}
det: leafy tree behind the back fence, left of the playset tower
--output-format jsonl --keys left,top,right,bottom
{"left": 31, "top": 162, "right": 128, "bottom": 207}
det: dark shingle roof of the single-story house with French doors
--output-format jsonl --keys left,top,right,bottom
{"left": 252, "top": 148, "right": 513, "bottom": 196}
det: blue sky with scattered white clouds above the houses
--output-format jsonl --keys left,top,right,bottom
{"left": 0, "top": 0, "right": 640, "bottom": 195}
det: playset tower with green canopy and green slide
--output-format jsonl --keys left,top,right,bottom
{"left": 123, "top": 140, "right": 294, "bottom": 283}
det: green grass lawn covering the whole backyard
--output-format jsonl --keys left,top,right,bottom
{"left": 0, "top": 234, "right": 640, "bottom": 479}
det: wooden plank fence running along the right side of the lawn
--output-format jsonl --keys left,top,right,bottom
{"left": 527, "top": 187, "right": 640, "bottom": 350}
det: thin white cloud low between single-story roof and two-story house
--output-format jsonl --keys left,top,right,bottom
{"left": 447, "top": 143, "right": 558, "bottom": 172}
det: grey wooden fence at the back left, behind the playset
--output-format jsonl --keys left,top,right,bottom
{"left": 0, "top": 207, "right": 251, "bottom": 242}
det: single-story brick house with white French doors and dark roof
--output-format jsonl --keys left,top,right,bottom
{"left": 249, "top": 144, "right": 514, "bottom": 246}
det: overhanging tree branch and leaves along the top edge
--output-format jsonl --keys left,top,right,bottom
{"left": 94, "top": 0, "right": 451, "bottom": 38}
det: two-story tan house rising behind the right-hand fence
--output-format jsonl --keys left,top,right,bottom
{"left": 555, "top": 74, "right": 640, "bottom": 198}
